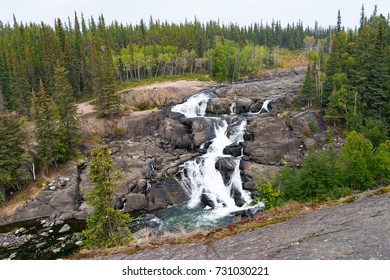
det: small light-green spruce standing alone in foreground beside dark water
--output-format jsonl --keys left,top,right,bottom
{"left": 83, "top": 146, "right": 131, "bottom": 247}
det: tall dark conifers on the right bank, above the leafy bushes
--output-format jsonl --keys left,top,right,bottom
{"left": 299, "top": 9, "right": 390, "bottom": 131}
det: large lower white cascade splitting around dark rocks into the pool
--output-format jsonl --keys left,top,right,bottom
{"left": 175, "top": 120, "right": 251, "bottom": 224}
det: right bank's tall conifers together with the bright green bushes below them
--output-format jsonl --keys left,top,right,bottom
{"left": 258, "top": 8, "right": 390, "bottom": 208}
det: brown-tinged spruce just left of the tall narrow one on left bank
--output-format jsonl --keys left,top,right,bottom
{"left": 32, "top": 80, "right": 67, "bottom": 174}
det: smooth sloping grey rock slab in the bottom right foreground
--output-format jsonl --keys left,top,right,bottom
{"left": 94, "top": 194, "right": 390, "bottom": 260}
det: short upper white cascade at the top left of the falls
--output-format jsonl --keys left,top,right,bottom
{"left": 171, "top": 92, "right": 215, "bottom": 118}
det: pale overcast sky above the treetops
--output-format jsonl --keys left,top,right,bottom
{"left": 0, "top": 0, "right": 390, "bottom": 27}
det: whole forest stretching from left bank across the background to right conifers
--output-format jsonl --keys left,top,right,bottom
{"left": 0, "top": 6, "right": 390, "bottom": 203}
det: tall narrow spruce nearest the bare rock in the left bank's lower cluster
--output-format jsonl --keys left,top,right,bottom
{"left": 53, "top": 64, "right": 81, "bottom": 156}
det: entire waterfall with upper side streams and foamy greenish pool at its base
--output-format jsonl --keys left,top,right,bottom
{"left": 160, "top": 92, "right": 271, "bottom": 229}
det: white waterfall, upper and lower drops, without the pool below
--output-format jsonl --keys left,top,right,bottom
{"left": 172, "top": 92, "right": 251, "bottom": 225}
